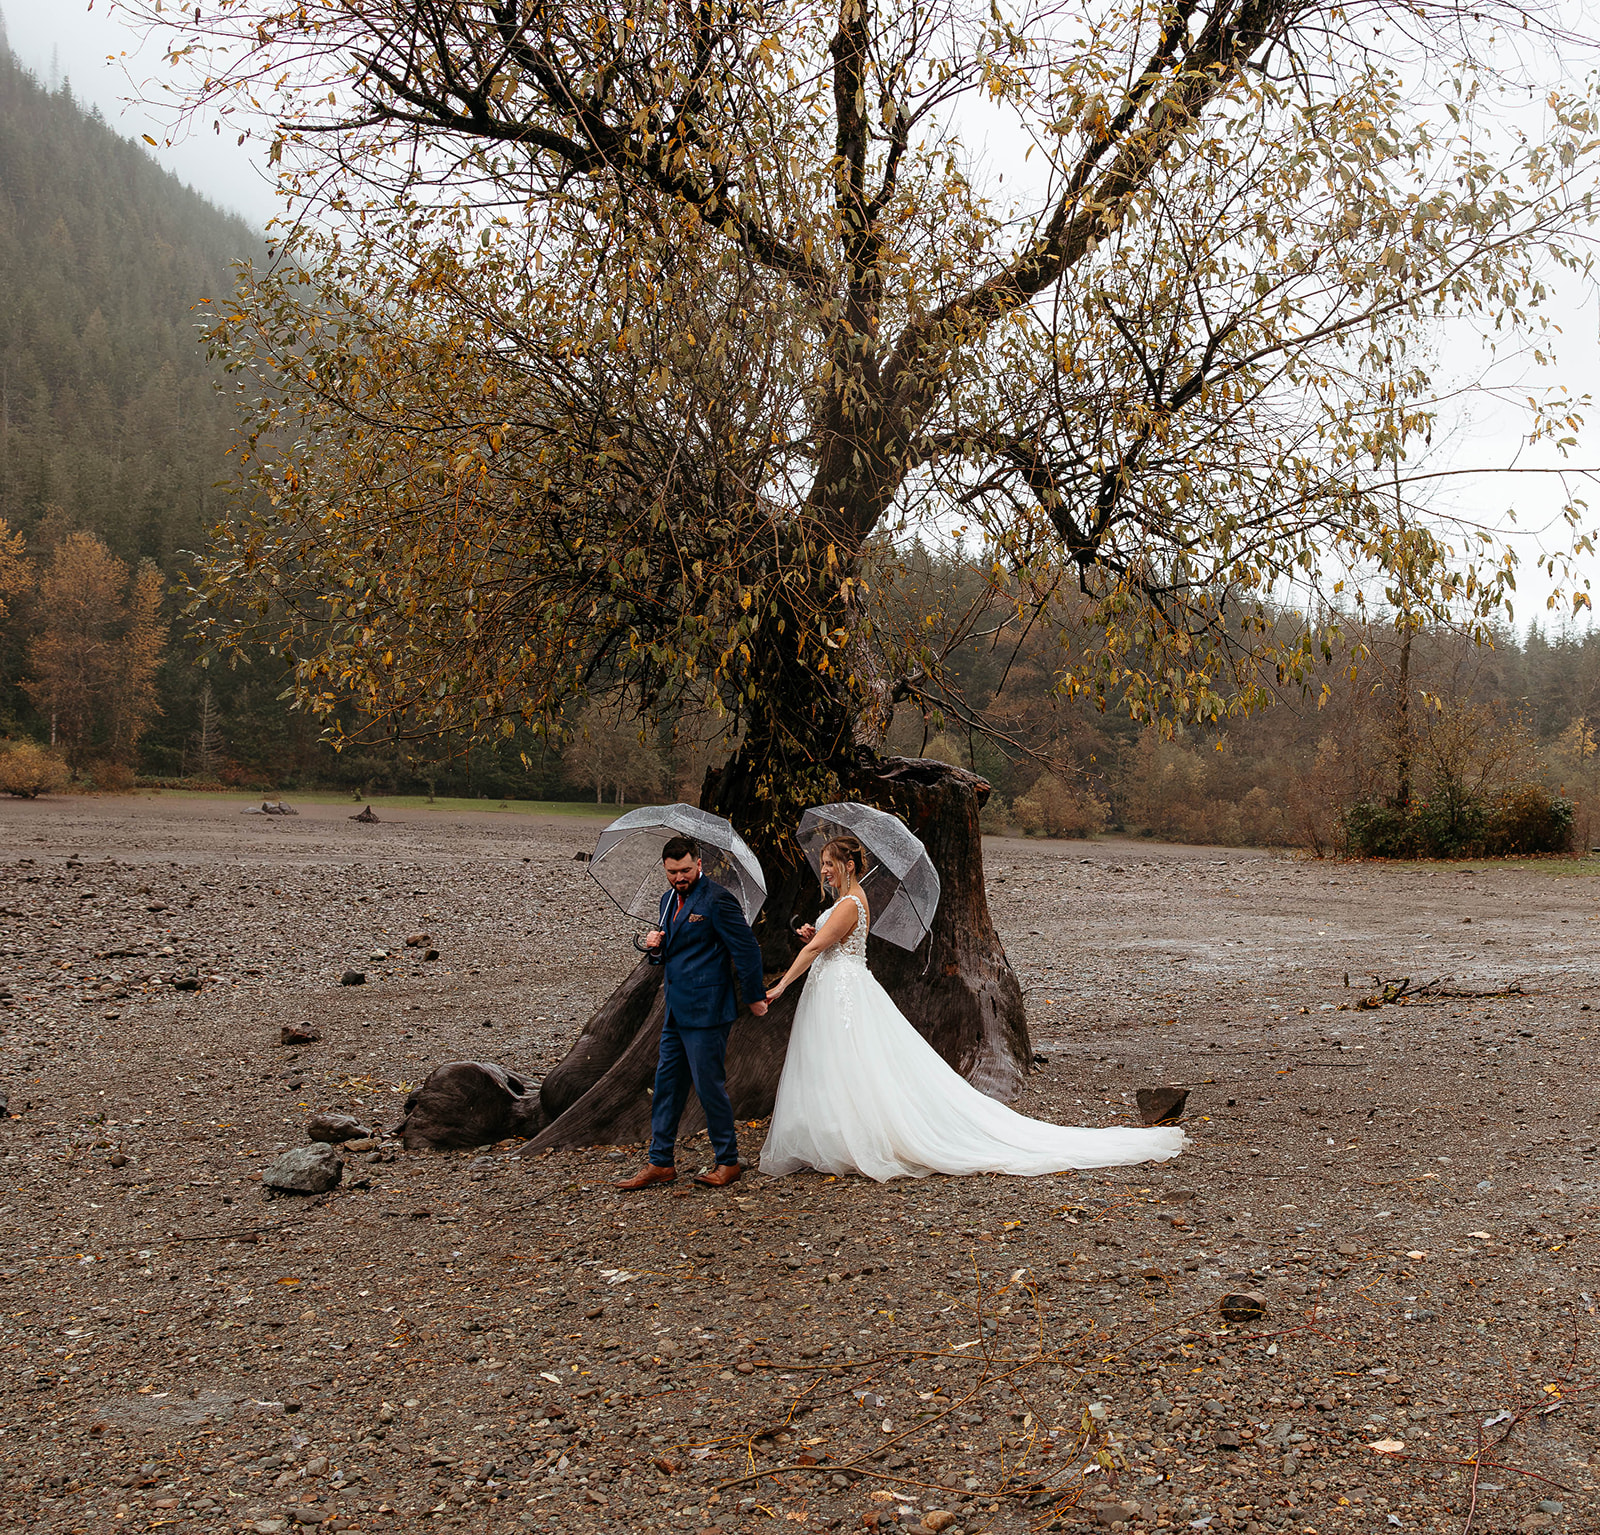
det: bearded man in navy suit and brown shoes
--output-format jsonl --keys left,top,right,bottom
{"left": 618, "top": 837, "right": 766, "bottom": 1189}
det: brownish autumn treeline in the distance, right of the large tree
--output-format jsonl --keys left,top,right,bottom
{"left": 888, "top": 552, "right": 1600, "bottom": 856}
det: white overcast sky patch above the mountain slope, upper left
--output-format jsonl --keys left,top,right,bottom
{"left": 0, "top": 0, "right": 277, "bottom": 226}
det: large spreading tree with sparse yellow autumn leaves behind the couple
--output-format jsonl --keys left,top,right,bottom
{"left": 134, "top": 0, "right": 1595, "bottom": 1143}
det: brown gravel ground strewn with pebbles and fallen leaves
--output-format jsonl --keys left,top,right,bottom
{"left": 0, "top": 796, "right": 1600, "bottom": 1535}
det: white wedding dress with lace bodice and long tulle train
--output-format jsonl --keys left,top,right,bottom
{"left": 762, "top": 896, "right": 1186, "bottom": 1181}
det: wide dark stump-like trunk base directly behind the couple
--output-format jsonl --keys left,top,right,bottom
{"left": 525, "top": 752, "right": 1032, "bottom": 1160}
